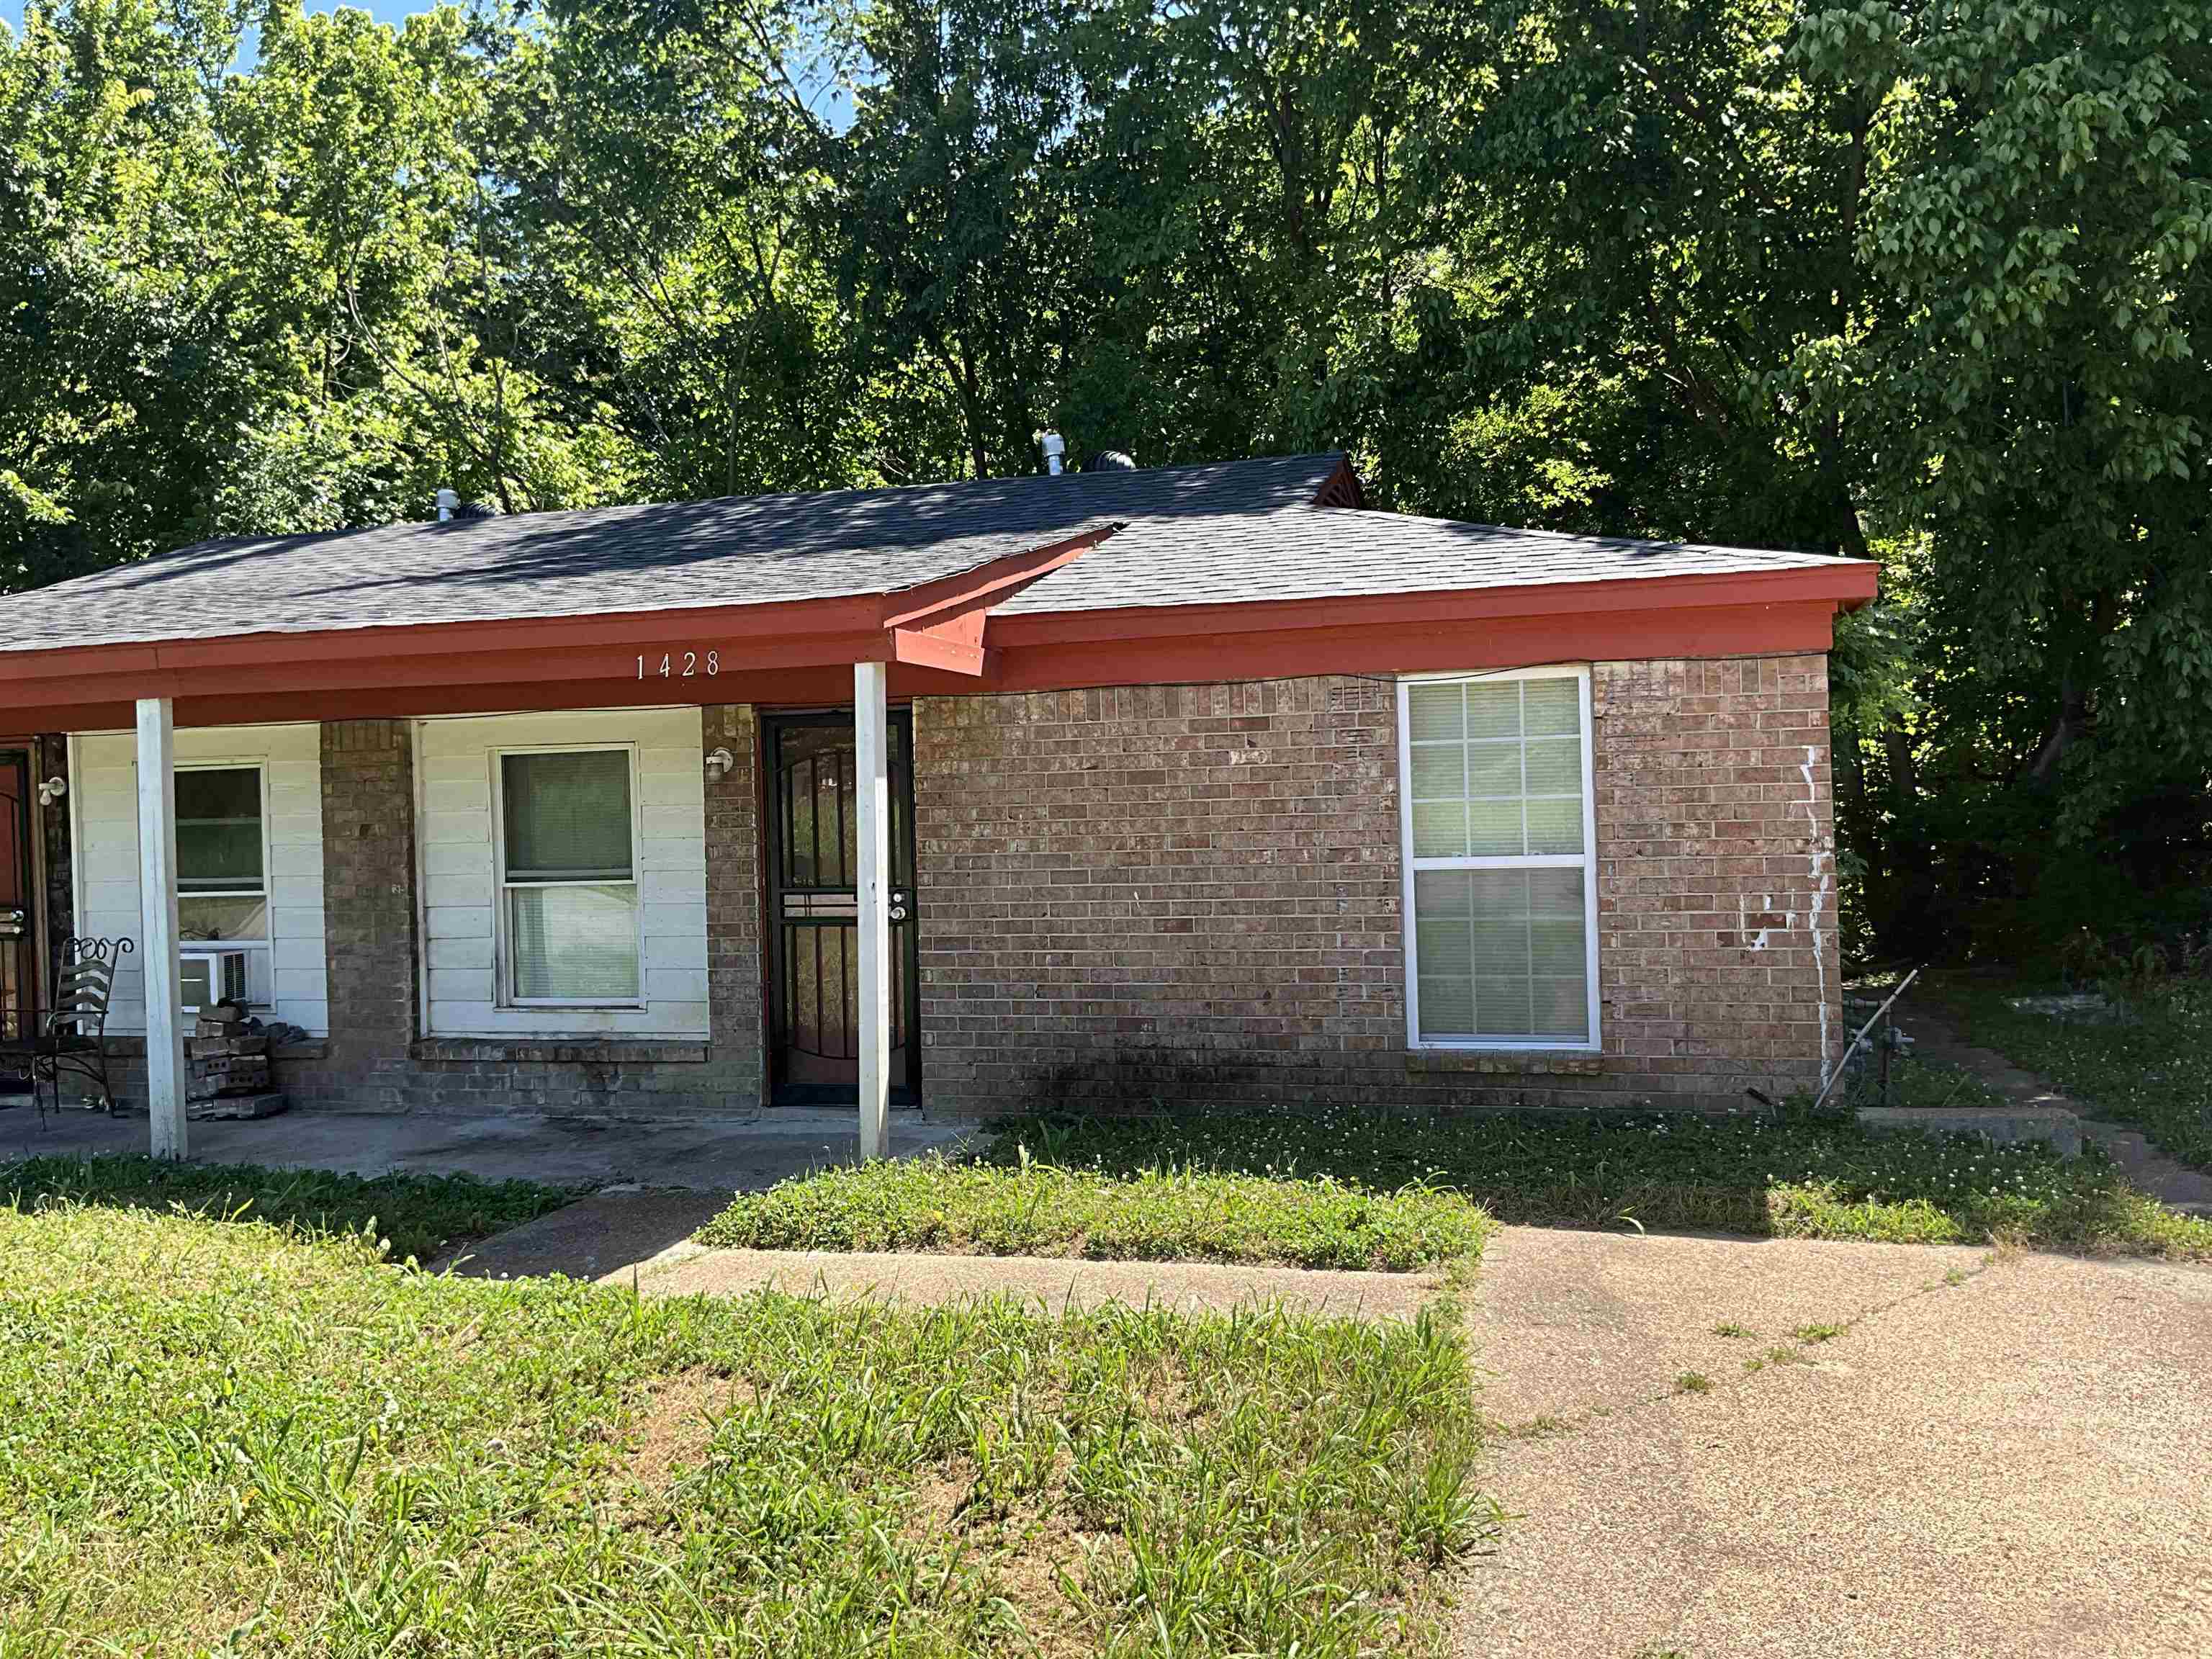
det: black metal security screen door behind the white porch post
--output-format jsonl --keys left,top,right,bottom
{"left": 765, "top": 710, "right": 922, "bottom": 1106}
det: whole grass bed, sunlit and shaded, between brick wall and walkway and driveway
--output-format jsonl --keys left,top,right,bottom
{"left": 699, "top": 1110, "right": 2212, "bottom": 1267}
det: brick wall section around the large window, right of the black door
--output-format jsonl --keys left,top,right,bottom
{"left": 916, "top": 657, "right": 1840, "bottom": 1112}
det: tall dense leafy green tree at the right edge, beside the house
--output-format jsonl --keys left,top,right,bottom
{"left": 1796, "top": 0, "right": 2212, "bottom": 951}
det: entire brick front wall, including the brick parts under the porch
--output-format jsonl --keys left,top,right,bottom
{"left": 81, "top": 657, "right": 1843, "bottom": 1115}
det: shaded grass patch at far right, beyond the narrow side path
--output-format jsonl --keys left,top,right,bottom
{"left": 1940, "top": 980, "right": 2212, "bottom": 1170}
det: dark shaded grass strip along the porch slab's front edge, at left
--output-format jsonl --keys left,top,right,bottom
{"left": 0, "top": 1157, "right": 577, "bottom": 1261}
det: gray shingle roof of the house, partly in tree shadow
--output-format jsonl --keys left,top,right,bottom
{"left": 0, "top": 456, "right": 1866, "bottom": 650}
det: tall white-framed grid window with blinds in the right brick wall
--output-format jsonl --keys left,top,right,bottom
{"left": 1398, "top": 668, "right": 1599, "bottom": 1051}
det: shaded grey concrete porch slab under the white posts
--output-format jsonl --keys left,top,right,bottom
{"left": 0, "top": 1106, "right": 976, "bottom": 1197}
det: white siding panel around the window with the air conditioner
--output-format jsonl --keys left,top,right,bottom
{"left": 68, "top": 726, "right": 330, "bottom": 1038}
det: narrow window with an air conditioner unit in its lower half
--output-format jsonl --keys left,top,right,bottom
{"left": 177, "top": 763, "right": 274, "bottom": 1011}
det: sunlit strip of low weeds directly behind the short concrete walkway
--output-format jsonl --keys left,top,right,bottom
{"left": 699, "top": 1137, "right": 1491, "bottom": 1272}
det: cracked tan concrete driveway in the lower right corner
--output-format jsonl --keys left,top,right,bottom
{"left": 1455, "top": 1228, "right": 2212, "bottom": 1659}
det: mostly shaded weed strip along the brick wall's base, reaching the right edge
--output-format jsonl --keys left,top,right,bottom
{"left": 950, "top": 1108, "right": 2212, "bottom": 1256}
